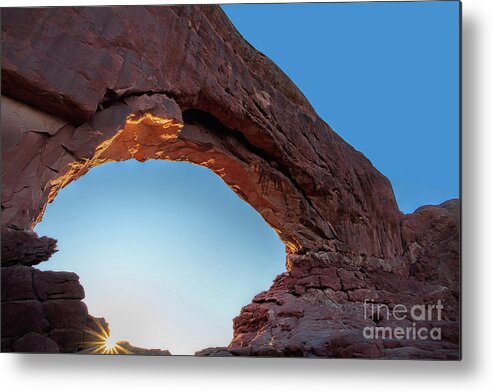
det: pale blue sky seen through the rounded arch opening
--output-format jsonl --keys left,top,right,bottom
{"left": 36, "top": 159, "right": 285, "bottom": 354}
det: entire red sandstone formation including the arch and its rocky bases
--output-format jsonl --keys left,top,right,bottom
{"left": 2, "top": 6, "right": 459, "bottom": 358}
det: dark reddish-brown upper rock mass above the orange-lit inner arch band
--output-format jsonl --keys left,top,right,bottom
{"left": 2, "top": 6, "right": 402, "bottom": 260}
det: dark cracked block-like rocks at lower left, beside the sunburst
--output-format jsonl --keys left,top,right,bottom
{"left": 2, "top": 266, "right": 90, "bottom": 353}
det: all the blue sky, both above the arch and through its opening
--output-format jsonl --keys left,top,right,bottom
{"left": 36, "top": 2, "right": 459, "bottom": 354}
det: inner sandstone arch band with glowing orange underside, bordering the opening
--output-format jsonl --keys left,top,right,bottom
{"left": 3, "top": 94, "right": 334, "bottom": 253}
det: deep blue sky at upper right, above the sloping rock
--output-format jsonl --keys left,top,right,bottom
{"left": 223, "top": 1, "right": 459, "bottom": 213}
